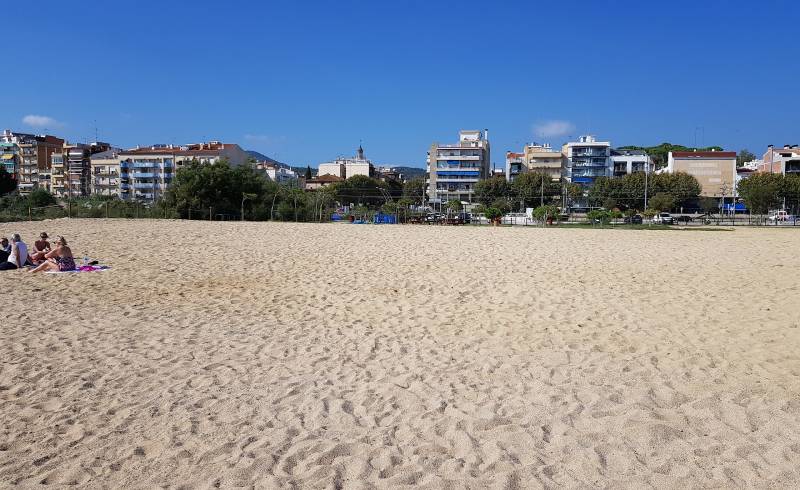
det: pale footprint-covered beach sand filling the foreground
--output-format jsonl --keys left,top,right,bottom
{"left": 0, "top": 220, "right": 800, "bottom": 489}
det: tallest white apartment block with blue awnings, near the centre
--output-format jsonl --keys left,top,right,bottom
{"left": 427, "top": 130, "right": 491, "bottom": 203}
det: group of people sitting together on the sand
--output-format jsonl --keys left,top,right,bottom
{"left": 0, "top": 232, "right": 75, "bottom": 272}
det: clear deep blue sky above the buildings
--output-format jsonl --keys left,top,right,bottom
{"left": 0, "top": 0, "right": 800, "bottom": 167}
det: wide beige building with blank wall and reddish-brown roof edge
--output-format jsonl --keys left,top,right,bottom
{"left": 666, "top": 151, "right": 736, "bottom": 197}
